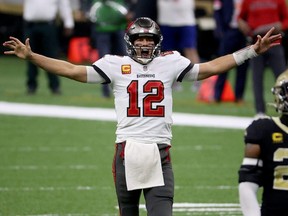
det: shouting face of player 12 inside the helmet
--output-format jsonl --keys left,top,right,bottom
{"left": 134, "top": 37, "right": 155, "bottom": 58}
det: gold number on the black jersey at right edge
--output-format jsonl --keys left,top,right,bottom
{"left": 273, "top": 148, "right": 288, "bottom": 190}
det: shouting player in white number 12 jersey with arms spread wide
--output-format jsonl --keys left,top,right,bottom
{"left": 4, "top": 17, "right": 281, "bottom": 216}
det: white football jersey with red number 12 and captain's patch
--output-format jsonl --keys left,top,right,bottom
{"left": 87, "top": 51, "right": 199, "bottom": 144}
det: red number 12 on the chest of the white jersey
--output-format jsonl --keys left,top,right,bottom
{"left": 127, "top": 80, "right": 165, "bottom": 117}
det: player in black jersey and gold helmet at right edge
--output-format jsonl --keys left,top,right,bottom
{"left": 239, "top": 70, "right": 288, "bottom": 216}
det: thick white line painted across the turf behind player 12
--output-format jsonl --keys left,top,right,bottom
{"left": 0, "top": 101, "right": 253, "bottom": 129}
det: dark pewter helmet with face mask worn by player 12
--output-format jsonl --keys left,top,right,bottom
{"left": 124, "top": 17, "right": 163, "bottom": 65}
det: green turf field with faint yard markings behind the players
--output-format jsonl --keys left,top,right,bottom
{"left": 0, "top": 56, "right": 275, "bottom": 216}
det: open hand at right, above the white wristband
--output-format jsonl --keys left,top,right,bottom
{"left": 252, "top": 27, "right": 282, "bottom": 54}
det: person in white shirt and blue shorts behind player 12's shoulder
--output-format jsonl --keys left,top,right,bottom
{"left": 157, "top": 0, "right": 200, "bottom": 90}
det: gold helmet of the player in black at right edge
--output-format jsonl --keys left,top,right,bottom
{"left": 271, "top": 70, "right": 288, "bottom": 115}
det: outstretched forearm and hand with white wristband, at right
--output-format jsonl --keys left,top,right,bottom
{"left": 198, "top": 27, "right": 282, "bottom": 80}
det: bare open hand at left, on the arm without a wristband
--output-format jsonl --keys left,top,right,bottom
{"left": 3, "top": 37, "right": 32, "bottom": 59}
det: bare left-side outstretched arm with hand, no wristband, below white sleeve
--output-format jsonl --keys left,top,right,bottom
{"left": 3, "top": 37, "right": 87, "bottom": 82}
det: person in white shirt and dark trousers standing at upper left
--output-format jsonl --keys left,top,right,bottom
{"left": 23, "top": 0, "right": 74, "bottom": 95}
